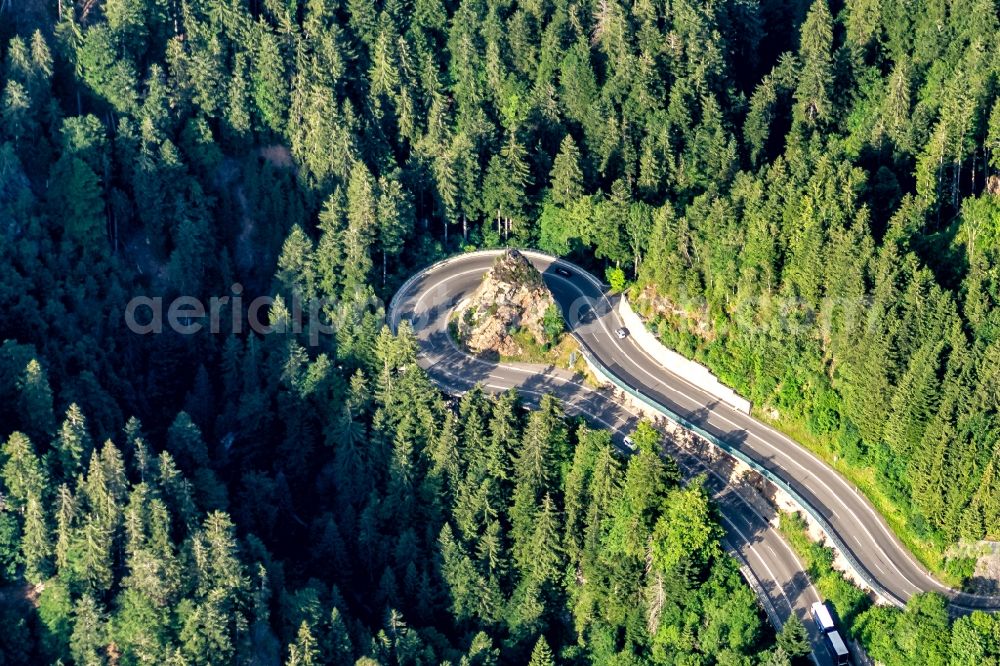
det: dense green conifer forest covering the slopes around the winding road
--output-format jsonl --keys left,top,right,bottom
{"left": 0, "top": 0, "right": 1000, "bottom": 666}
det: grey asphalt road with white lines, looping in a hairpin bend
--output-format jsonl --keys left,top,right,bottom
{"left": 388, "top": 250, "right": 1000, "bottom": 652}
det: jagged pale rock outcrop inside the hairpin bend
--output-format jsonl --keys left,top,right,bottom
{"left": 458, "top": 250, "right": 554, "bottom": 356}
